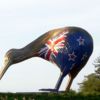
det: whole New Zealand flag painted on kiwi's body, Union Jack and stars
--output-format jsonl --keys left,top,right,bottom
{"left": 39, "top": 30, "right": 92, "bottom": 75}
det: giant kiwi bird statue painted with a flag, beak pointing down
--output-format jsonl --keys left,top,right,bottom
{"left": 0, "top": 27, "right": 93, "bottom": 92}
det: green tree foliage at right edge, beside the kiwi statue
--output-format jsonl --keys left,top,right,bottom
{"left": 79, "top": 57, "right": 100, "bottom": 94}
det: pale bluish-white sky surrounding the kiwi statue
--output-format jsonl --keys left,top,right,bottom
{"left": 0, "top": 0, "right": 100, "bottom": 92}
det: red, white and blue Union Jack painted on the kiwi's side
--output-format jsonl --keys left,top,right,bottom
{"left": 39, "top": 32, "right": 67, "bottom": 62}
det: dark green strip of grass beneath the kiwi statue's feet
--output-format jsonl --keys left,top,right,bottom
{"left": 0, "top": 92, "right": 100, "bottom": 100}
